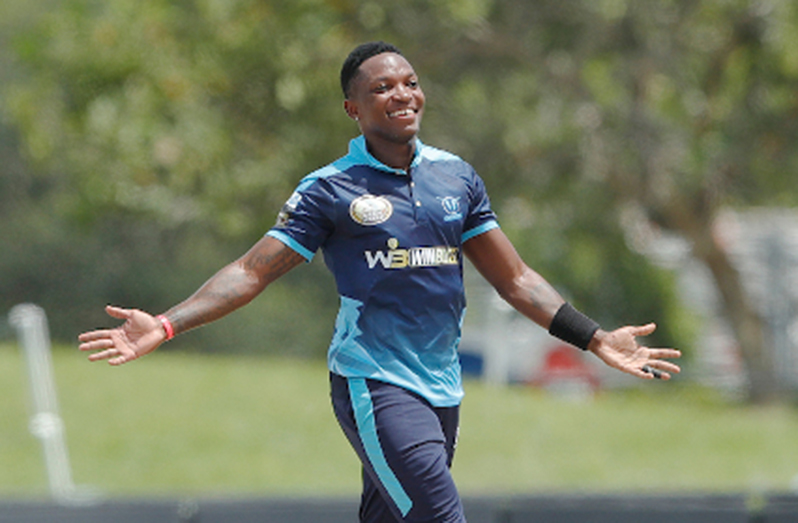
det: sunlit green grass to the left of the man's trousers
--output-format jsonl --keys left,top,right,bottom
{"left": 0, "top": 347, "right": 360, "bottom": 496}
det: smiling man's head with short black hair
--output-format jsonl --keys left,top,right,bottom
{"left": 344, "top": 53, "right": 424, "bottom": 144}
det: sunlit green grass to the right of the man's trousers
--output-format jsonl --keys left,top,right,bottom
{"left": 455, "top": 383, "right": 798, "bottom": 493}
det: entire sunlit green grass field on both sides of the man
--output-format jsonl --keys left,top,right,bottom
{"left": 0, "top": 345, "right": 798, "bottom": 497}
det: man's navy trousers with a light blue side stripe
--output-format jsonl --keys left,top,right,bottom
{"left": 330, "top": 373, "right": 465, "bottom": 523}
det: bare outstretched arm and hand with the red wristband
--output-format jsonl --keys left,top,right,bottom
{"left": 78, "top": 236, "right": 305, "bottom": 365}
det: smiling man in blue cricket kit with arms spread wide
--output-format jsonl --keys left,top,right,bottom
{"left": 80, "top": 42, "right": 680, "bottom": 522}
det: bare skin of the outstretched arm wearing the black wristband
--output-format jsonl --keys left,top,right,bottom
{"left": 463, "top": 229, "right": 681, "bottom": 379}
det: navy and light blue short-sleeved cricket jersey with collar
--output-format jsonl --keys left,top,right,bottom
{"left": 267, "top": 136, "right": 498, "bottom": 407}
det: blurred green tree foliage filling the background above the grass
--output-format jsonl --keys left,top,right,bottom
{"left": 0, "top": 0, "right": 798, "bottom": 364}
